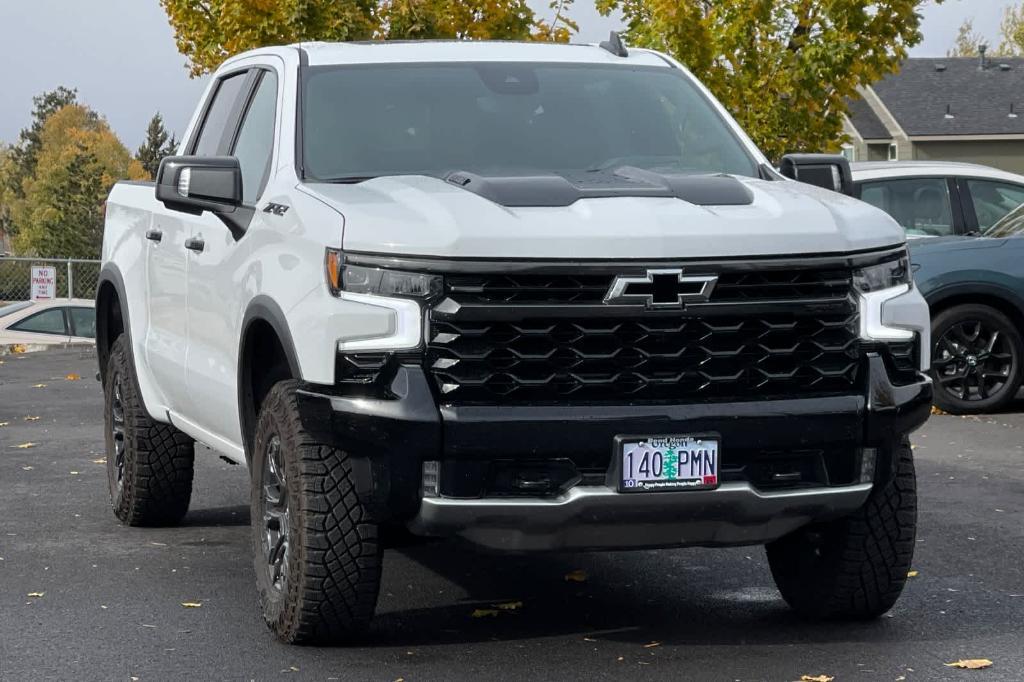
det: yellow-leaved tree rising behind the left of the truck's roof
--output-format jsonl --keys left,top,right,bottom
{"left": 160, "top": 0, "right": 575, "bottom": 76}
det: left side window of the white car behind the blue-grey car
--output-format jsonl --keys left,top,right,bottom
{"left": 860, "top": 177, "right": 954, "bottom": 237}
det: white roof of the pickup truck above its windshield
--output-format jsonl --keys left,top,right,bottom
{"left": 293, "top": 40, "right": 673, "bottom": 68}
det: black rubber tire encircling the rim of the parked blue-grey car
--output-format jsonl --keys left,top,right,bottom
{"left": 931, "top": 303, "right": 1024, "bottom": 415}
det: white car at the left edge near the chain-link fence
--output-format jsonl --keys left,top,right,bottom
{"left": 0, "top": 298, "right": 96, "bottom": 345}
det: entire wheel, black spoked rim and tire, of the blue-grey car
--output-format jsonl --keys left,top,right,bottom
{"left": 932, "top": 304, "right": 1024, "bottom": 415}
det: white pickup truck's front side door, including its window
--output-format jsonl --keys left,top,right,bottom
{"left": 186, "top": 68, "right": 279, "bottom": 445}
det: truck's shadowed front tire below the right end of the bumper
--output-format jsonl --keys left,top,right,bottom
{"left": 767, "top": 440, "right": 918, "bottom": 619}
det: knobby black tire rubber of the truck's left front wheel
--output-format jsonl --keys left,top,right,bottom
{"left": 251, "top": 381, "right": 382, "bottom": 644}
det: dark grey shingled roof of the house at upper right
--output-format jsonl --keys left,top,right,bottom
{"left": 850, "top": 57, "right": 1024, "bottom": 139}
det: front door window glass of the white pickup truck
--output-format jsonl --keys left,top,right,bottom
{"left": 233, "top": 71, "right": 278, "bottom": 204}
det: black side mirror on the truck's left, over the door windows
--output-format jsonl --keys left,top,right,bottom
{"left": 157, "top": 157, "right": 242, "bottom": 215}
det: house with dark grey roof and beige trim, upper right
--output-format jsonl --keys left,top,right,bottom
{"left": 844, "top": 54, "right": 1024, "bottom": 174}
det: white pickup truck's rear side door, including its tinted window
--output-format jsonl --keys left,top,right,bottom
{"left": 145, "top": 72, "right": 248, "bottom": 417}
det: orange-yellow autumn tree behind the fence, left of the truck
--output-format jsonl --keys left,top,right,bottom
{"left": 12, "top": 104, "right": 146, "bottom": 258}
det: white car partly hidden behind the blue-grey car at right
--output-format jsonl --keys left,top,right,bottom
{"left": 850, "top": 161, "right": 1024, "bottom": 237}
